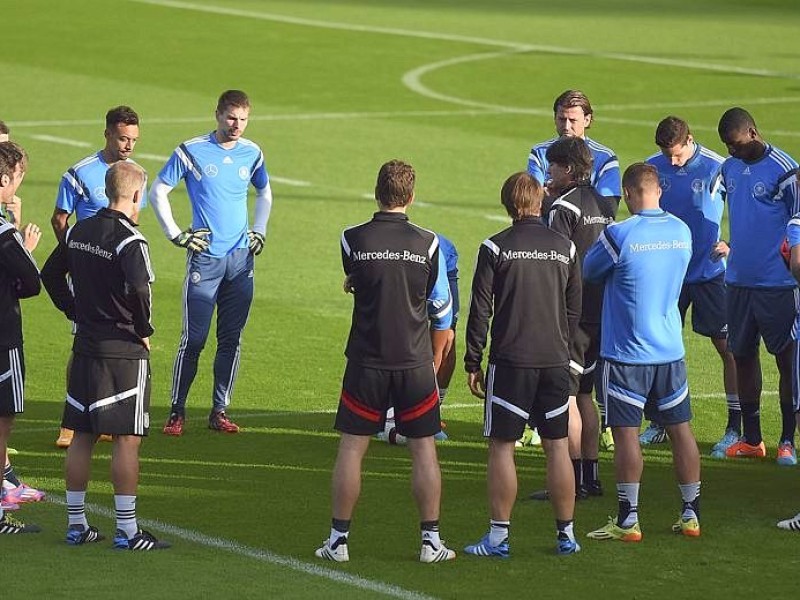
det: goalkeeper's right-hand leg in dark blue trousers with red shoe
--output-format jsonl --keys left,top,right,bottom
{"left": 209, "top": 248, "right": 253, "bottom": 433}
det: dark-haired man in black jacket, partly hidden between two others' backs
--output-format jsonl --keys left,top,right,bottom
{"left": 531, "top": 137, "right": 618, "bottom": 500}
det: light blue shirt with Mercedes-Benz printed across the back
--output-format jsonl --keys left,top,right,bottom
{"left": 583, "top": 210, "right": 692, "bottom": 365}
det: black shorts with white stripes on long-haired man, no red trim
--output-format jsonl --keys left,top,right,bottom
{"left": 483, "top": 363, "right": 569, "bottom": 441}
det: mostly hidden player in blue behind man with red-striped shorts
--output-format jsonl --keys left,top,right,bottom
{"left": 380, "top": 233, "right": 461, "bottom": 444}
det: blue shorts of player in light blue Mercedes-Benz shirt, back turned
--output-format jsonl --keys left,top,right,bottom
{"left": 596, "top": 358, "right": 692, "bottom": 427}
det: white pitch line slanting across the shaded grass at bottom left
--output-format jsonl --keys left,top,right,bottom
{"left": 47, "top": 494, "right": 435, "bottom": 600}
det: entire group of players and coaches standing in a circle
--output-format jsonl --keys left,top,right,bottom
{"left": 0, "top": 90, "right": 800, "bottom": 563}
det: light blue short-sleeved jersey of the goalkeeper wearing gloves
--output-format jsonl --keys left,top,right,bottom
{"left": 158, "top": 131, "right": 269, "bottom": 257}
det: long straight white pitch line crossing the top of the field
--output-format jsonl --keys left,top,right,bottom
{"left": 129, "top": 0, "right": 800, "bottom": 79}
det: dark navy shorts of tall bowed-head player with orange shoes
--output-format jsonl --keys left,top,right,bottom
{"left": 728, "top": 286, "right": 798, "bottom": 357}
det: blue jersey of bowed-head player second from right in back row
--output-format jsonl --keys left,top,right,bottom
{"left": 647, "top": 144, "right": 725, "bottom": 283}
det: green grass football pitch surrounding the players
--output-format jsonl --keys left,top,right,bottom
{"left": 0, "top": 0, "right": 800, "bottom": 598}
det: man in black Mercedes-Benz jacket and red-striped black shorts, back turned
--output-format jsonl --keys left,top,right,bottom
{"left": 315, "top": 160, "right": 456, "bottom": 563}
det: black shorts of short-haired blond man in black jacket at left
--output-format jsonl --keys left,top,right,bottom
{"left": 61, "top": 354, "right": 150, "bottom": 436}
